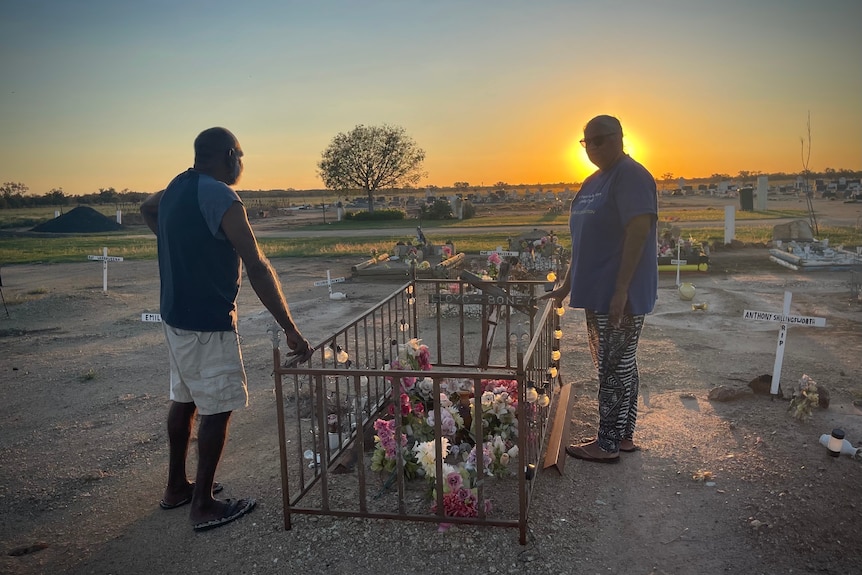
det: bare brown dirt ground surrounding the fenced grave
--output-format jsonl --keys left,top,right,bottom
{"left": 0, "top": 196, "right": 862, "bottom": 575}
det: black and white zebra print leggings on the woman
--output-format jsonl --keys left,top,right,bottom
{"left": 584, "top": 310, "right": 644, "bottom": 453}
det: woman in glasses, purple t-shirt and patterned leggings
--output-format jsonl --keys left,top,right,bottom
{"left": 545, "top": 116, "right": 658, "bottom": 463}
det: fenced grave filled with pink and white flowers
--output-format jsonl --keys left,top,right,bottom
{"left": 272, "top": 270, "right": 573, "bottom": 544}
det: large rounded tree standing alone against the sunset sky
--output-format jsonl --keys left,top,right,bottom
{"left": 317, "top": 124, "right": 425, "bottom": 211}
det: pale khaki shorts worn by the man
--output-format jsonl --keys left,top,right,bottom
{"left": 163, "top": 324, "right": 248, "bottom": 415}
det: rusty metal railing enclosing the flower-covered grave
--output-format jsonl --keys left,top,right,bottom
{"left": 272, "top": 278, "right": 565, "bottom": 544}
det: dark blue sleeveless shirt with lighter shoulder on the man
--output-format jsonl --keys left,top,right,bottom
{"left": 158, "top": 170, "right": 241, "bottom": 331}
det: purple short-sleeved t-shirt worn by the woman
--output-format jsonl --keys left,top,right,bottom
{"left": 569, "top": 155, "right": 658, "bottom": 315}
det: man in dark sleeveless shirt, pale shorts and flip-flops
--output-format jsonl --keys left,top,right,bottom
{"left": 141, "top": 128, "right": 313, "bottom": 531}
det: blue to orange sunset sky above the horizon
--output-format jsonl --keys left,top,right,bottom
{"left": 0, "top": 0, "right": 862, "bottom": 198}
